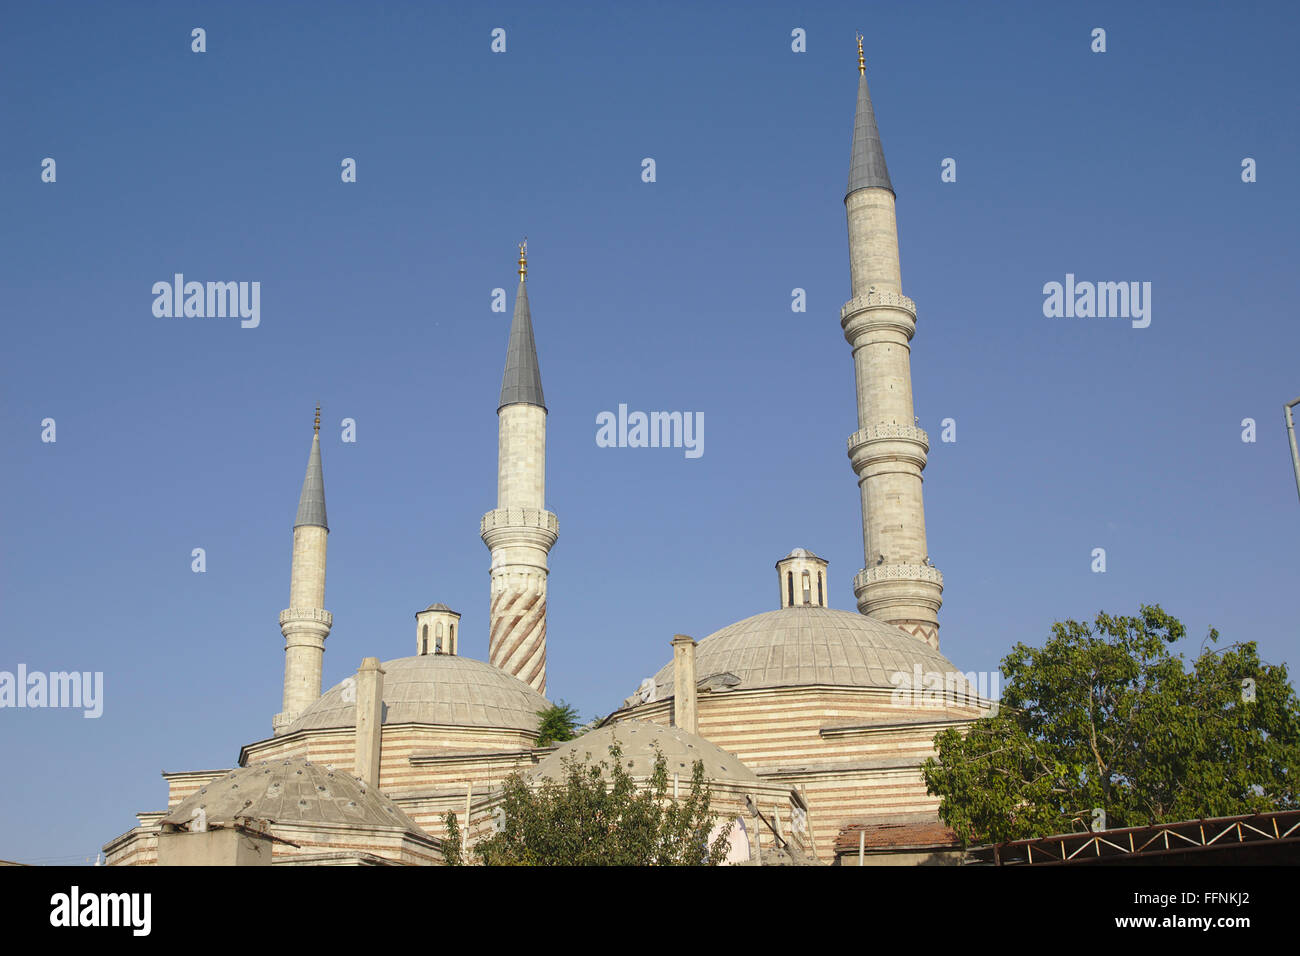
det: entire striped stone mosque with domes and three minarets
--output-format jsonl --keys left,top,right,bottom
{"left": 104, "top": 36, "right": 991, "bottom": 865}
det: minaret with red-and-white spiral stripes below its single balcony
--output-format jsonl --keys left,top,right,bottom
{"left": 480, "top": 239, "right": 559, "bottom": 695}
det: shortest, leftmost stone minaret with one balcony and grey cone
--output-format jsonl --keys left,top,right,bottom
{"left": 272, "top": 405, "right": 334, "bottom": 734}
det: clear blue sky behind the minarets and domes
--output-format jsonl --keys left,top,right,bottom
{"left": 0, "top": 3, "right": 1300, "bottom": 861}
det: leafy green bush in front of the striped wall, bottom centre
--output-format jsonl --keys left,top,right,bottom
{"left": 445, "top": 741, "right": 732, "bottom": 866}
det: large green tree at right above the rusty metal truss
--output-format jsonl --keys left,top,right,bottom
{"left": 923, "top": 605, "right": 1300, "bottom": 843}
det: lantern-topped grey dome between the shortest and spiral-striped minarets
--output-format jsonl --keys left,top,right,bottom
{"left": 286, "top": 654, "right": 550, "bottom": 734}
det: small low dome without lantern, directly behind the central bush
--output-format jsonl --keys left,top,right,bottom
{"left": 530, "top": 721, "right": 761, "bottom": 787}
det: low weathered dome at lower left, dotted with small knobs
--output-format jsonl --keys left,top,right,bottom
{"left": 161, "top": 757, "right": 420, "bottom": 832}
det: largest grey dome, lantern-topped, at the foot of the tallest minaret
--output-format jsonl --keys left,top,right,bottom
{"left": 644, "top": 606, "right": 965, "bottom": 700}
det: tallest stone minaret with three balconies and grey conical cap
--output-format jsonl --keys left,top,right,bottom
{"left": 840, "top": 34, "right": 944, "bottom": 649}
